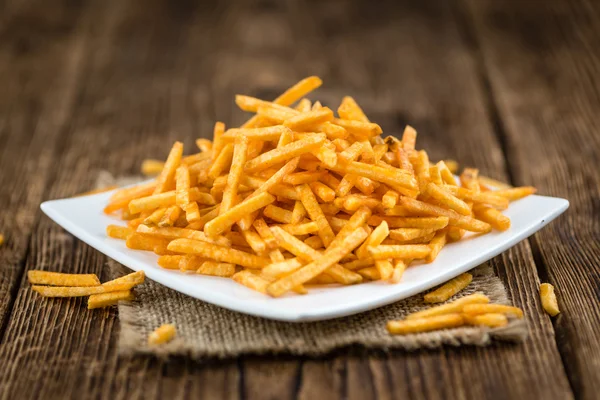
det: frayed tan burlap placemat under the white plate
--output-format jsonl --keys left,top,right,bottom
{"left": 99, "top": 174, "right": 527, "bottom": 359}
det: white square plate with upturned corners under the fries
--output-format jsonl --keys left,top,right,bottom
{"left": 41, "top": 192, "right": 569, "bottom": 322}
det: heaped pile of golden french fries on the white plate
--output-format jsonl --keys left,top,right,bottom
{"left": 105, "top": 77, "right": 535, "bottom": 297}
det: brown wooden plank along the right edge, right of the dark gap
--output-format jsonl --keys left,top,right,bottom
{"left": 469, "top": 1, "right": 600, "bottom": 399}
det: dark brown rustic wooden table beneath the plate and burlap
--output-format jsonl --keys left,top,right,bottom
{"left": 0, "top": 0, "right": 600, "bottom": 399}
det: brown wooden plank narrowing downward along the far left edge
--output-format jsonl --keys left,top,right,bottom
{"left": 0, "top": 2, "right": 86, "bottom": 338}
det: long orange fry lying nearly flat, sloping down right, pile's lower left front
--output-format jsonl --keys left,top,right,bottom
{"left": 168, "top": 239, "right": 270, "bottom": 269}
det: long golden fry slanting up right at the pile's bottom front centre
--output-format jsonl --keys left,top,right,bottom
{"left": 267, "top": 229, "right": 367, "bottom": 297}
